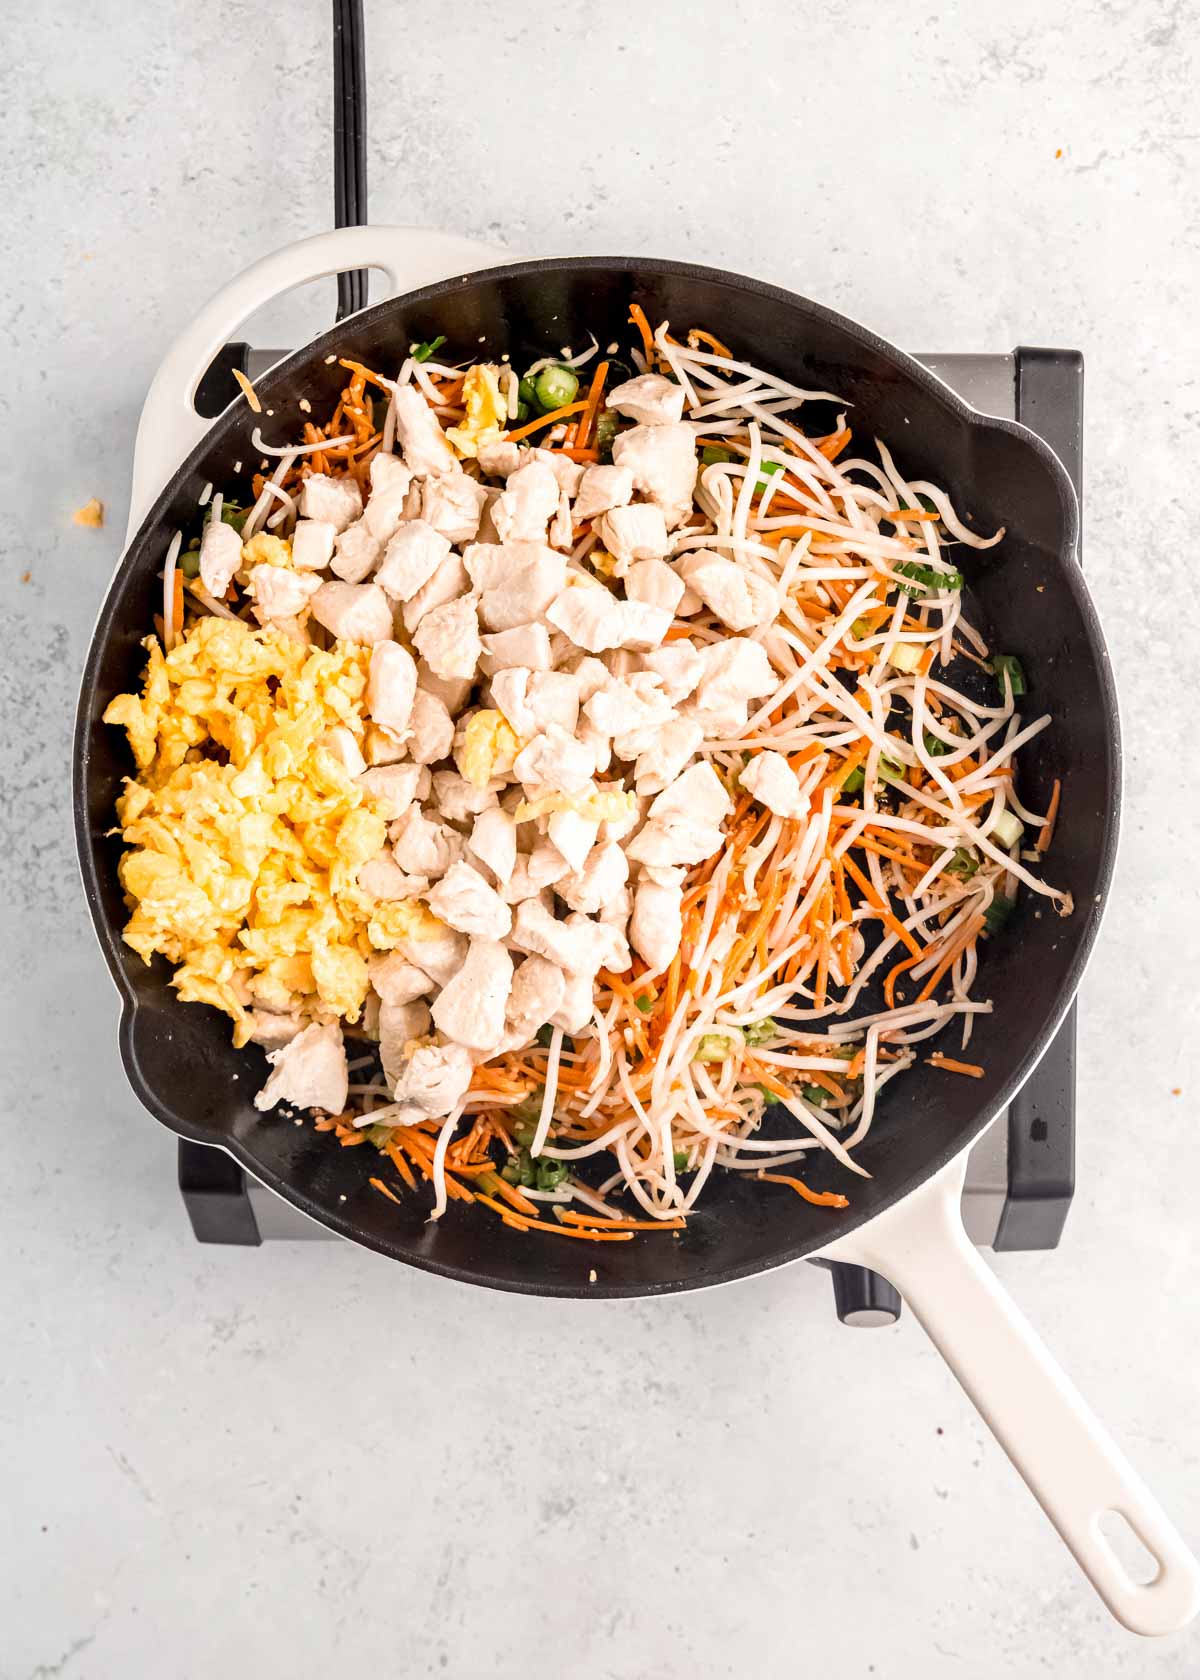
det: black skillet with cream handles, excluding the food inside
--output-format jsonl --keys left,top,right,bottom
{"left": 74, "top": 228, "right": 1200, "bottom": 1633}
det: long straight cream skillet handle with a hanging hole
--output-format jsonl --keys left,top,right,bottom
{"left": 824, "top": 1156, "right": 1200, "bottom": 1635}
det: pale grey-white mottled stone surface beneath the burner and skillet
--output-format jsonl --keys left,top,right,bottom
{"left": 0, "top": 0, "right": 1200, "bottom": 1680}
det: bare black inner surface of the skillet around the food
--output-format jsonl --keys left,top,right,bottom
{"left": 76, "top": 257, "right": 1119, "bottom": 1295}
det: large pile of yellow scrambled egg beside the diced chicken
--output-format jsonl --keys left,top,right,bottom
{"left": 104, "top": 614, "right": 442, "bottom": 1043}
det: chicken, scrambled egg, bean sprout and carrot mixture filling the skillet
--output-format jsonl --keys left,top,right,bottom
{"left": 106, "top": 307, "right": 1071, "bottom": 1242}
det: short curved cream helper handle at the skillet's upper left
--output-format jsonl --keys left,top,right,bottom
{"left": 126, "top": 227, "right": 513, "bottom": 544}
